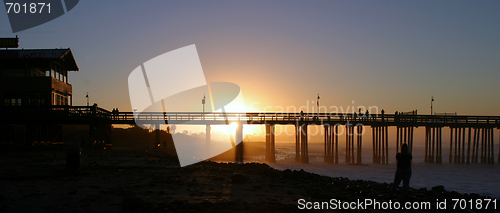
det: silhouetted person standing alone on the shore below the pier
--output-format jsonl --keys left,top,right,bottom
{"left": 389, "top": 144, "right": 412, "bottom": 198}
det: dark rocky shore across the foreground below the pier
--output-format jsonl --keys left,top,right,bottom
{"left": 0, "top": 150, "right": 500, "bottom": 212}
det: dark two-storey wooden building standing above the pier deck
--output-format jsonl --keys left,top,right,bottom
{"left": 0, "top": 48, "right": 78, "bottom": 106}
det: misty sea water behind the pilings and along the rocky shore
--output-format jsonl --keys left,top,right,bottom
{"left": 238, "top": 142, "right": 500, "bottom": 198}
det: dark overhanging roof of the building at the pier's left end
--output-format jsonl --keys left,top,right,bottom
{"left": 0, "top": 48, "right": 78, "bottom": 71}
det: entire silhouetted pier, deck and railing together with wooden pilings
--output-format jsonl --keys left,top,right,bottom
{"left": 1, "top": 105, "right": 500, "bottom": 164}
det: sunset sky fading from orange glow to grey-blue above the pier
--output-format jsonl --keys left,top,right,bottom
{"left": 0, "top": 0, "right": 500, "bottom": 115}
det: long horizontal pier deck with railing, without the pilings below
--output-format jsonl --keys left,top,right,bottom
{"left": 0, "top": 106, "right": 500, "bottom": 126}
